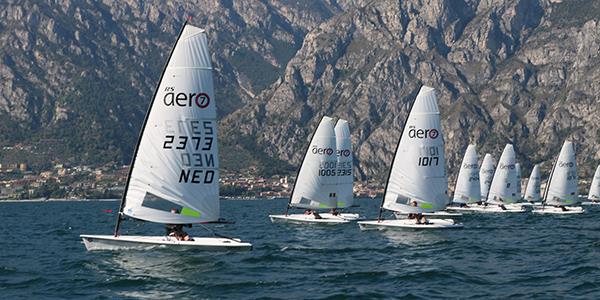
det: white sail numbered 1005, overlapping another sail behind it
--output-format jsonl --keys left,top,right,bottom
{"left": 291, "top": 117, "right": 337, "bottom": 209}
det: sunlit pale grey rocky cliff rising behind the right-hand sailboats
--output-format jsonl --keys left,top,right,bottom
{"left": 221, "top": 0, "right": 600, "bottom": 178}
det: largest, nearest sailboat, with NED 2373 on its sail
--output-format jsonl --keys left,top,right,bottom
{"left": 80, "top": 22, "right": 252, "bottom": 250}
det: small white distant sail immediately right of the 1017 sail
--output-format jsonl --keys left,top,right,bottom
{"left": 452, "top": 145, "right": 481, "bottom": 203}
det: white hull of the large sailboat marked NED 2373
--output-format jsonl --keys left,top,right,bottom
{"left": 80, "top": 234, "right": 252, "bottom": 251}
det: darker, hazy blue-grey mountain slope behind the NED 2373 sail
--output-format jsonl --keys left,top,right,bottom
{"left": 0, "top": 0, "right": 341, "bottom": 162}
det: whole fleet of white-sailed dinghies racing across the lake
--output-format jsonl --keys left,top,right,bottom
{"left": 81, "top": 22, "right": 600, "bottom": 250}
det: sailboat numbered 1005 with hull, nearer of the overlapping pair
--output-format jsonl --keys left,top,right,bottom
{"left": 269, "top": 116, "right": 349, "bottom": 224}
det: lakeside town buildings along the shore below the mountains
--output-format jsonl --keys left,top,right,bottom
{"left": 0, "top": 162, "right": 384, "bottom": 200}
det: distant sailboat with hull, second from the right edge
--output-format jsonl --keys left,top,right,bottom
{"left": 533, "top": 141, "right": 584, "bottom": 214}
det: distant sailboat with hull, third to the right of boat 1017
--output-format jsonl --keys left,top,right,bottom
{"left": 482, "top": 144, "right": 525, "bottom": 212}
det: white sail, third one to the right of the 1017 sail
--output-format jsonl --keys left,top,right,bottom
{"left": 487, "top": 144, "right": 520, "bottom": 204}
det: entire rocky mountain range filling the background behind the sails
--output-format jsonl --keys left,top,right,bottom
{"left": 0, "top": 0, "right": 600, "bottom": 183}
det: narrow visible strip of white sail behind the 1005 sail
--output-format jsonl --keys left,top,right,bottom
{"left": 335, "top": 119, "right": 354, "bottom": 208}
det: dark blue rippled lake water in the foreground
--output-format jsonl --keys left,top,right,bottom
{"left": 0, "top": 199, "right": 600, "bottom": 299}
